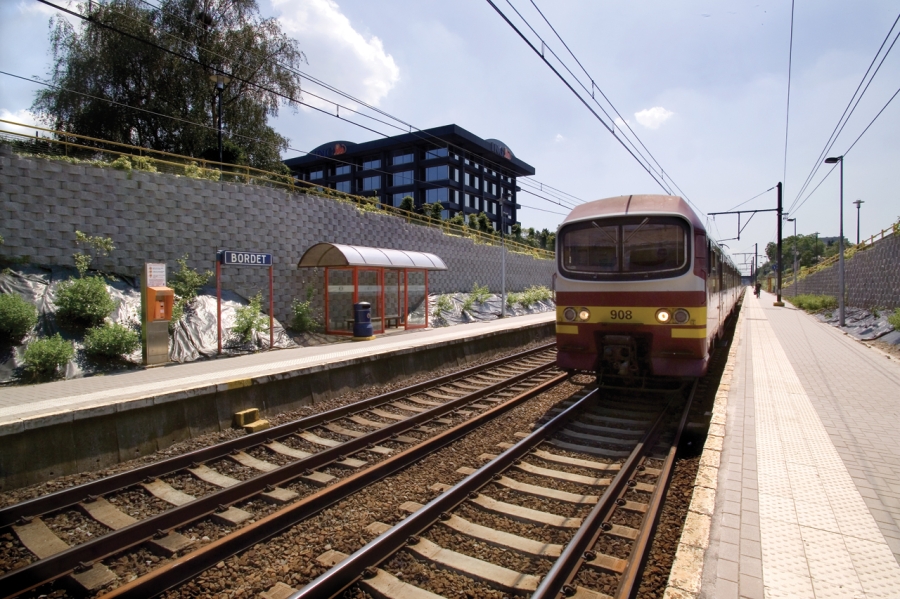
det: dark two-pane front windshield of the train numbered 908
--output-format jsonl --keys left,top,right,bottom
{"left": 558, "top": 216, "right": 690, "bottom": 280}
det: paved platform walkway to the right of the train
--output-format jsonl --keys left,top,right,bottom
{"left": 701, "top": 293, "right": 900, "bottom": 599}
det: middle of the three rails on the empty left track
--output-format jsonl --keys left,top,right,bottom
{"left": 0, "top": 362, "right": 556, "bottom": 597}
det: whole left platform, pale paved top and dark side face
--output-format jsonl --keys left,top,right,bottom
{"left": 0, "top": 311, "right": 556, "bottom": 490}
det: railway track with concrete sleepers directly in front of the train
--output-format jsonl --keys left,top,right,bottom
{"left": 292, "top": 383, "right": 697, "bottom": 599}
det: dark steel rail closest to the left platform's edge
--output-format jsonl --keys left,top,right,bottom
{"left": 0, "top": 342, "right": 555, "bottom": 530}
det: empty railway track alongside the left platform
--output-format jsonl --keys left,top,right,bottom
{"left": 0, "top": 345, "right": 565, "bottom": 597}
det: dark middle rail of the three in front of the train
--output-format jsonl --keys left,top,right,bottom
{"left": 531, "top": 379, "right": 698, "bottom": 599}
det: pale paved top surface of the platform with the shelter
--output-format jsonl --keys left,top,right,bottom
{"left": 0, "top": 312, "right": 556, "bottom": 434}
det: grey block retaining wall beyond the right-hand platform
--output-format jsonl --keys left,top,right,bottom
{"left": 783, "top": 234, "right": 900, "bottom": 310}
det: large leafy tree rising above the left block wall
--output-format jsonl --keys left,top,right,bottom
{"left": 32, "top": 0, "right": 305, "bottom": 170}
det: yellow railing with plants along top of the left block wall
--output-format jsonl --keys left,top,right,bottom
{"left": 0, "top": 119, "right": 555, "bottom": 260}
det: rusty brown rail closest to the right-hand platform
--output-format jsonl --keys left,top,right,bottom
{"left": 616, "top": 381, "right": 697, "bottom": 599}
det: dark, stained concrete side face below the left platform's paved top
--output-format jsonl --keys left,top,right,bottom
{"left": 0, "top": 322, "right": 556, "bottom": 491}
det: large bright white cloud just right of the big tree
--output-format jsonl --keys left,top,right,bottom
{"left": 272, "top": 0, "right": 400, "bottom": 105}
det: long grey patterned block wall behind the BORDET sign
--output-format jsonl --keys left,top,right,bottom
{"left": 0, "top": 145, "right": 554, "bottom": 321}
